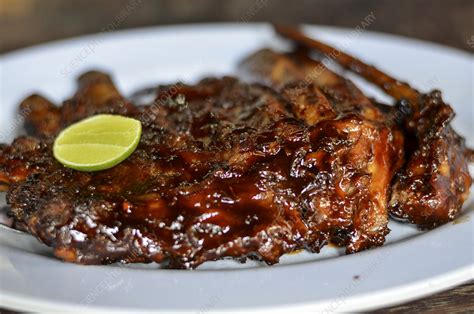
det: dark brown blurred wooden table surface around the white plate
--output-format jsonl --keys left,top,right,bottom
{"left": 0, "top": 0, "right": 474, "bottom": 313}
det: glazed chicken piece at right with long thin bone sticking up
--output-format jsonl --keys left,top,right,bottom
{"left": 275, "top": 25, "right": 474, "bottom": 228}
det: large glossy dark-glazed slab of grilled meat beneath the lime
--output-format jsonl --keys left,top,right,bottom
{"left": 2, "top": 72, "right": 404, "bottom": 267}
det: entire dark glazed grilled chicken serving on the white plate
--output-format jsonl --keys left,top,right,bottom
{"left": 0, "top": 27, "right": 471, "bottom": 268}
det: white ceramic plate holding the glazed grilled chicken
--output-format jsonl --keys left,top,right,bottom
{"left": 0, "top": 24, "right": 474, "bottom": 313}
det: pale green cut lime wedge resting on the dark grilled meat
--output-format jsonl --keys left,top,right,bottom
{"left": 53, "top": 114, "right": 142, "bottom": 171}
